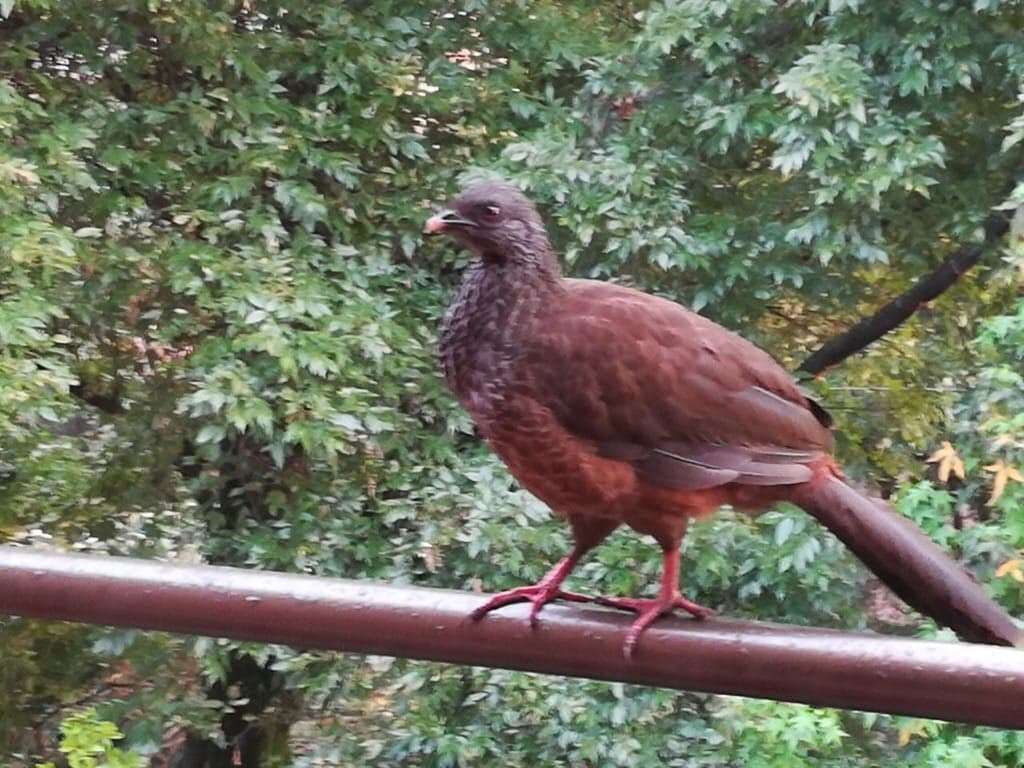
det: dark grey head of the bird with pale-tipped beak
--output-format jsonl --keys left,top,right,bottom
{"left": 423, "top": 181, "right": 554, "bottom": 265}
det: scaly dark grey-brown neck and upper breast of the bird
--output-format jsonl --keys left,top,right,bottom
{"left": 438, "top": 256, "right": 563, "bottom": 403}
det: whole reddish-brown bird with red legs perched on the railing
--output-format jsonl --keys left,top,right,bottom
{"left": 424, "top": 182, "right": 1024, "bottom": 656}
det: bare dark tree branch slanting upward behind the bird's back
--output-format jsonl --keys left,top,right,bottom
{"left": 798, "top": 213, "right": 1010, "bottom": 376}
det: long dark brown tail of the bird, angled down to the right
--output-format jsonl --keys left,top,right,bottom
{"left": 791, "top": 472, "right": 1024, "bottom": 647}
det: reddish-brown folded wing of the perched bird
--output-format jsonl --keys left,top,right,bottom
{"left": 516, "top": 280, "right": 831, "bottom": 489}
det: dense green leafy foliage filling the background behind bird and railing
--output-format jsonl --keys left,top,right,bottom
{"left": 0, "top": 0, "right": 1024, "bottom": 768}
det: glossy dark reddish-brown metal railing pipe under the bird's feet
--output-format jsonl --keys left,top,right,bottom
{"left": 0, "top": 547, "right": 1024, "bottom": 728}
